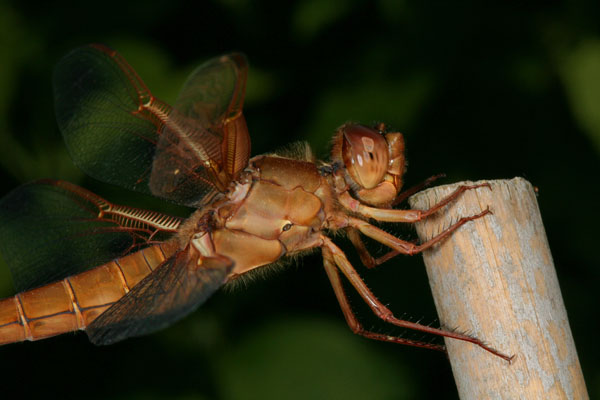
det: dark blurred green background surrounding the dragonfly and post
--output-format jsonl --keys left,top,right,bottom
{"left": 0, "top": 0, "right": 600, "bottom": 399}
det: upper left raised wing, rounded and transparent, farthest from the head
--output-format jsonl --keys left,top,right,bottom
{"left": 54, "top": 45, "right": 170, "bottom": 200}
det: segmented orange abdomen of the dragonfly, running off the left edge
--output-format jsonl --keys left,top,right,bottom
{"left": 0, "top": 242, "right": 176, "bottom": 344}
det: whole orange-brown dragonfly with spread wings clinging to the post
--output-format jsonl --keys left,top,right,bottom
{"left": 0, "top": 44, "right": 510, "bottom": 360}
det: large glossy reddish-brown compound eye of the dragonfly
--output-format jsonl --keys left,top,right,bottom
{"left": 342, "top": 125, "right": 389, "bottom": 189}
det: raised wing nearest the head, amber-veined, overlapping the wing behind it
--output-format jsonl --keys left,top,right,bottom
{"left": 150, "top": 53, "right": 250, "bottom": 206}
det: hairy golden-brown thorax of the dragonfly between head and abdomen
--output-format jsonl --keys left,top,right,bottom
{"left": 189, "top": 156, "right": 333, "bottom": 278}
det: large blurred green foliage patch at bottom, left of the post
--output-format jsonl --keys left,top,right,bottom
{"left": 217, "top": 317, "right": 415, "bottom": 400}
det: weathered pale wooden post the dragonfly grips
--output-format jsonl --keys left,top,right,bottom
{"left": 409, "top": 178, "right": 588, "bottom": 400}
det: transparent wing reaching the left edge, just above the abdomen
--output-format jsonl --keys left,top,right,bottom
{"left": 0, "top": 180, "right": 181, "bottom": 291}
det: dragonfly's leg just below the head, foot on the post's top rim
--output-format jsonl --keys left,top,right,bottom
{"left": 338, "top": 183, "right": 491, "bottom": 223}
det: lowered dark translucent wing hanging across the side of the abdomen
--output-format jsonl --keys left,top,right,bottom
{"left": 86, "top": 248, "right": 233, "bottom": 345}
